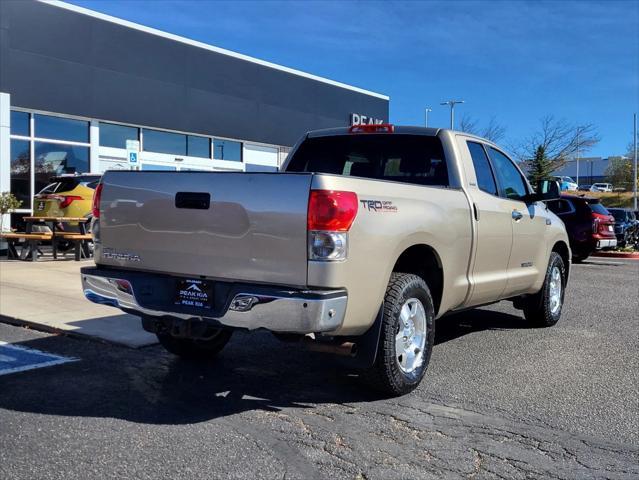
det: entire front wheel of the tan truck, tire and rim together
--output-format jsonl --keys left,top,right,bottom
{"left": 524, "top": 252, "right": 566, "bottom": 327}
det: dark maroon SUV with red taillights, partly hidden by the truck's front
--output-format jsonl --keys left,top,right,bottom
{"left": 547, "top": 195, "right": 617, "bottom": 262}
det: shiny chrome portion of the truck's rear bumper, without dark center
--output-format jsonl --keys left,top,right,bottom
{"left": 82, "top": 272, "right": 348, "bottom": 334}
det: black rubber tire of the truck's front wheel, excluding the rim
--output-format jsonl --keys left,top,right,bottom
{"left": 524, "top": 252, "right": 566, "bottom": 327}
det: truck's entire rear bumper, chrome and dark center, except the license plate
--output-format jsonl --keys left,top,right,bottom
{"left": 81, "top": 267, "right": 348, "bottom": 334}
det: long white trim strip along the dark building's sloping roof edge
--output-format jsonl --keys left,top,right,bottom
{"left": 38, "top": 0, "right": 390, "bottom": 101}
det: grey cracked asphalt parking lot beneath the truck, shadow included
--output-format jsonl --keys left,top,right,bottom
{"left": 0, "top": 259, "right": 639, "bottom": 479}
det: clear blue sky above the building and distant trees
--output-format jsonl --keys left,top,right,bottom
{"left": 72, "top": 0, "right": 639, "bottom": 156}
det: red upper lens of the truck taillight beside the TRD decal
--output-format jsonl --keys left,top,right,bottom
{"left": 307, "top": 190, "right": 358, "bottom": 232}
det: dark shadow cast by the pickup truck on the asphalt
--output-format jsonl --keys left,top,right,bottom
{"left": 0, "top": 310, "right": 525, "bottom": 425}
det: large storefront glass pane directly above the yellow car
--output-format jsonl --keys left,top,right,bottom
{"left": 34, "top": 142, "right": 89, "bottom": 192}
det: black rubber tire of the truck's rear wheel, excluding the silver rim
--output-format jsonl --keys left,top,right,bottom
{"left": 363, "top": 273, "right": 435, "bottom": 396}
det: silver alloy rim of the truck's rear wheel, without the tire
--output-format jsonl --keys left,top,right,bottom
{"left": 395, "top": 298, "right": 426, "bottom": 373}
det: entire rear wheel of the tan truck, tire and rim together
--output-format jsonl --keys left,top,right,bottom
{"left": 364, "top": 273, "right": 435, "bottom": 396}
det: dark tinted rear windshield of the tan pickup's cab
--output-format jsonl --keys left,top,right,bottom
{"left": 286, "top": 134, "right": 449, "bottom": 186}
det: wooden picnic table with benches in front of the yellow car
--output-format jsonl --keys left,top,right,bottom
{"left": 2, "top": 217, "right": 92, "bottom": 262}
